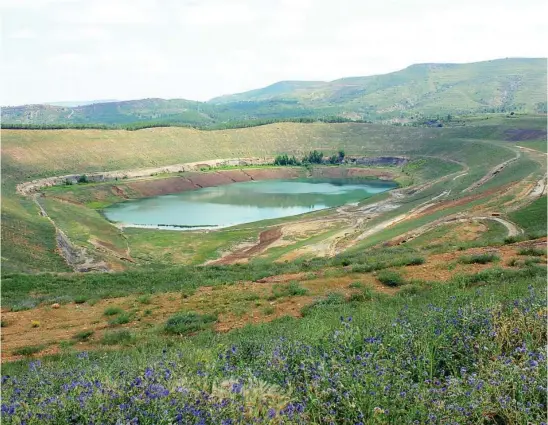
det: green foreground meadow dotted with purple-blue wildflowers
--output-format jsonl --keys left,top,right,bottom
{"left": 2, "top": 265, "right": 547, "bottom": 424}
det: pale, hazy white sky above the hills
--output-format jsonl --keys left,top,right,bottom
{"left": 0, "top": 0, "right": 548, "bottom": 105}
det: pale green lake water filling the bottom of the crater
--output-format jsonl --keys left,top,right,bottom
{"left": 104, "top": 179, "right": 397, "bottom": 228}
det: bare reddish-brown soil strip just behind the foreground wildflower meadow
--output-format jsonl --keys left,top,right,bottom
{"left": 2, "top": 274, "right": 395, "bottom": 361}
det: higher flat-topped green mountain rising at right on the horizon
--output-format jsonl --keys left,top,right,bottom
{"left": 210, "top": 58, "right": 546, "bottom": 118}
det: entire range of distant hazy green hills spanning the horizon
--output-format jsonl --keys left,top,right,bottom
{"left": 2, "top": 58, "right": 547, "bottom": 127}
